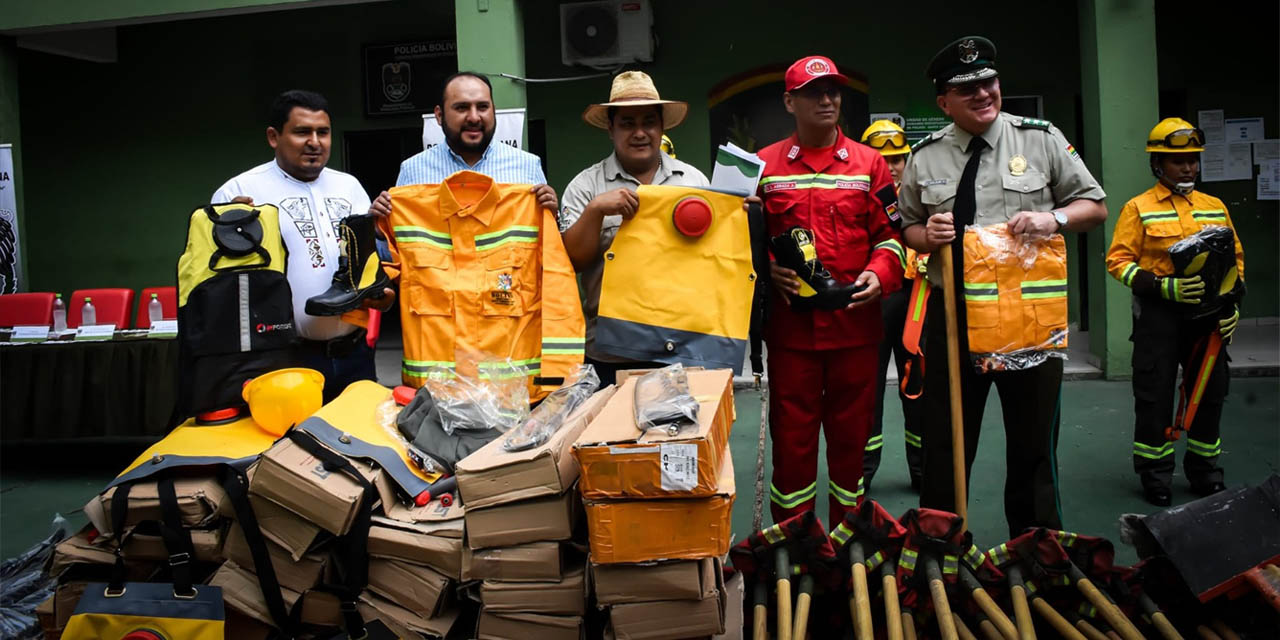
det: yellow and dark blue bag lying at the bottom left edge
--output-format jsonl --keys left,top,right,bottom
{"left": 63, "top": 582, "right": 224, "bottom": 640}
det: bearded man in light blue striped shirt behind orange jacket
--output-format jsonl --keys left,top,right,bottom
{"left": 371, "top": 72, "right": 559, "bottom": 215}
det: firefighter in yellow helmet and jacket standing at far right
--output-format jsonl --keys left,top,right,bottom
{"left": 1107, "top": 118, "right": 1244, "bottom": 507}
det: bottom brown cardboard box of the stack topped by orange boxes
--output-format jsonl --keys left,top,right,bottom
{"left": 609, "top": 572, "right": 724, "bottom": 640}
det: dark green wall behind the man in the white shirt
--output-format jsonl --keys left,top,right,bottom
{"left": 18, "top": 0, "right": 453, "bottom": 293}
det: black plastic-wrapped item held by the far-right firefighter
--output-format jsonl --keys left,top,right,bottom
{"left": 1169, "top": 225, "right": 1244, "bottom": 317}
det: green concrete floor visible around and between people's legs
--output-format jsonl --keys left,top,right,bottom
{"left": 0, "top": 376, "right": 1280, "bottom": 562}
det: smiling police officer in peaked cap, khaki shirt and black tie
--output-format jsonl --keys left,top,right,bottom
{"left": 899, "top": 36, "right": 1107, "bottom": 535}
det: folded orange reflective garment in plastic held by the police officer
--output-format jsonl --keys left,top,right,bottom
{"left": 964, "top": 224, "right": 1066, "bottom": 353}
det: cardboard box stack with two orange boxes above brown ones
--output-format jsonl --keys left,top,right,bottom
{"left": 573, "top": 370, "right": 735, "bottom": 640}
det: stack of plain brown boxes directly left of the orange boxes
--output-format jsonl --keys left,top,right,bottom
{"left": 457, "top": 387, "right": 614, "bottom": 640}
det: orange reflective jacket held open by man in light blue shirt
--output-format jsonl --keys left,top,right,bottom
{"left": 379, "top": 172, "right": 585, "bottom": 401}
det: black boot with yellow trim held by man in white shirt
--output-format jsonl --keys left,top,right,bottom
{"left": 306, "top": 214, "right": 392, "bottom": 316}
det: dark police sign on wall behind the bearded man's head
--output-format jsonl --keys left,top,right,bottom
{"left": 364, "top": 40, "right": 458, "bottom": 115}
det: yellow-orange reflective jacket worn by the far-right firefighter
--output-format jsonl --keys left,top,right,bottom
{"left": 1107, "top": 182, "right": 1244, "bottom": 287}
